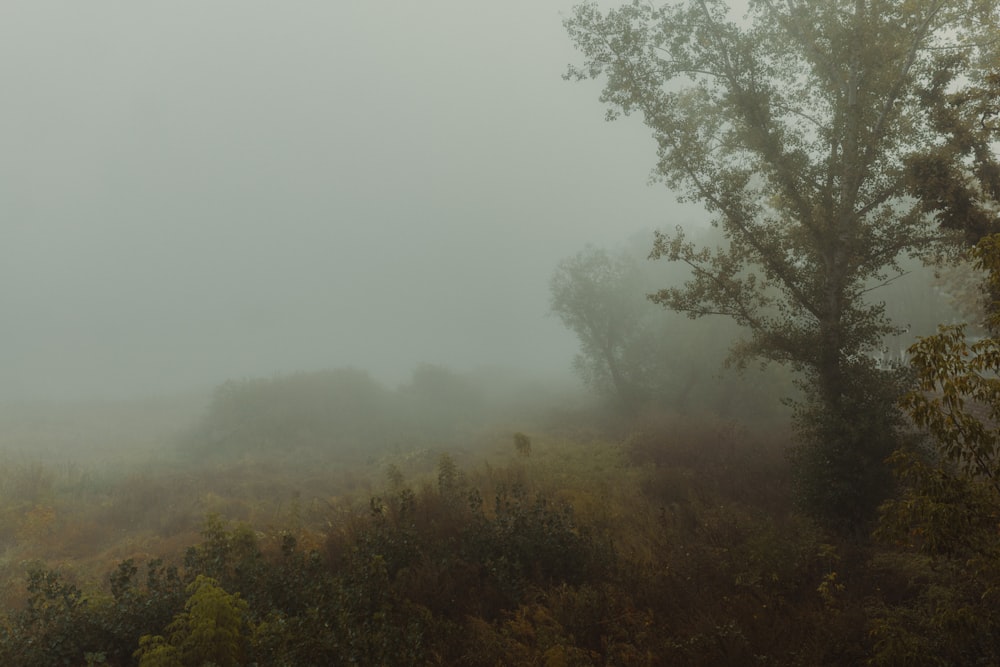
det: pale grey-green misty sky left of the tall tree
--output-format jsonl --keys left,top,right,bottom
{"left": 0, "top": 0, "right": 698, "bottom": 398}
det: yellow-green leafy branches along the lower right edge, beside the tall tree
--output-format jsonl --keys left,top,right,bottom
{"left": 871, "top": 237, "right": 1000, "bottom": 665}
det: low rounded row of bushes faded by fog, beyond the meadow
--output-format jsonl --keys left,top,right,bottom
{"left": 182, "top": 364, "right": 566, "bottom": 458}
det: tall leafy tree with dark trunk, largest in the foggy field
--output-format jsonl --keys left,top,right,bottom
{"left": 566, "top": 0, "right": 998, "bottom": 522}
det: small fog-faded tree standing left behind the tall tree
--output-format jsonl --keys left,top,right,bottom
{"left": 550, "top": 247, "right": 663, "bottom": 410}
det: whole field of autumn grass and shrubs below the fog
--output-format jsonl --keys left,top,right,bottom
{"left": 0, "top": 384, "right": 994, "bottom": 667}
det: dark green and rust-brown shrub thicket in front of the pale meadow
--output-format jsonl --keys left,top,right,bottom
{"left": 0, "top": 419, "right": 908, "bottom": 666}
